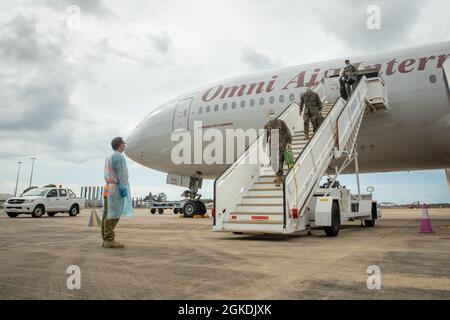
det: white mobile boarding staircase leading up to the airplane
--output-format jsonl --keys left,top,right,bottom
{"left": 213, "top": 74, "right": 389, "bottom": 234}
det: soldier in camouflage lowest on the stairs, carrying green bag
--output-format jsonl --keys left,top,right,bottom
{"left": 264, "top": 111, "right": 292, "bottom": 187}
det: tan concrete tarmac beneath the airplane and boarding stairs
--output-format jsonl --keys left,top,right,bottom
{"left": 0, "top": 209, "right": 450, "bottom": 300}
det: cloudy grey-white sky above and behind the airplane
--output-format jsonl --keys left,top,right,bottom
{"left": 0, "top": 0, "right": 450, "bottom": 202}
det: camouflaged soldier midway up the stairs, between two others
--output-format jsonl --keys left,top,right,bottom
{"left": 300, "top": 87, "right": 323, "bottom": 140}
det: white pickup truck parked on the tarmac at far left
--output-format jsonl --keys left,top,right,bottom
{"left": 5, "top": 188, "right": 85, "bottom": 218}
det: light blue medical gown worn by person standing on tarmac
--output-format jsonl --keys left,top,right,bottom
{"left": 105, "top": 151, "right": 134, "bottom": 219}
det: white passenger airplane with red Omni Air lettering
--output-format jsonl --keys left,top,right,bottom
{"left": 126, "top": 42, "right": 450, "bottom": 214}
